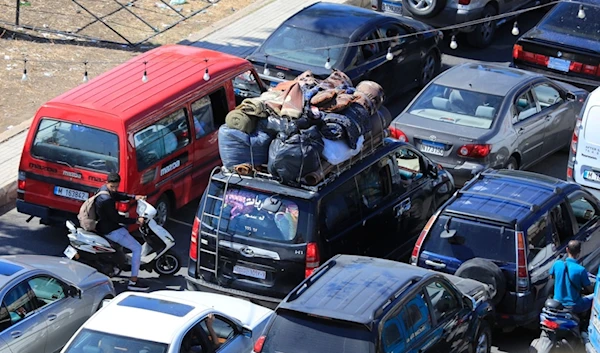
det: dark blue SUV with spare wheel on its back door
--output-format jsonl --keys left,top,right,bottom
{"left": 411, "top": 170, "right": 600, "bottom": 327}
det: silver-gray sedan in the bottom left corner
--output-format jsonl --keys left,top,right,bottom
{"left": 0, "top": 255, "right": 115, "bottom": 353}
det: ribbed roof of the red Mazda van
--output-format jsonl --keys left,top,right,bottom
{"left": 46, "top": 45, "right": 251, "bottom": 124}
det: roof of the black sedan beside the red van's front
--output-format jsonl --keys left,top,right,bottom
{"left": 284, "top": 2, "right": 388, "bottom": 38}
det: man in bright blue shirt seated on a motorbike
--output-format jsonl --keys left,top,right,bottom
{"left": 550, "top": 240, "right": 594, "bottom": 313}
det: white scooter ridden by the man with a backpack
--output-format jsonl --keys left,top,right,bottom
{"left": 64, "top": 200, "right": 181, "bottom": 277}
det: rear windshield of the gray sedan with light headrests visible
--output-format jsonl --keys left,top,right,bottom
{"left": 407, "top": 84, "right": 504, "bottom": 129}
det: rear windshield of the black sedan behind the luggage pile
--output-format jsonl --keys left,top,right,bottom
{"left": 263, "top": 25, "right": 349, "bottom": 66}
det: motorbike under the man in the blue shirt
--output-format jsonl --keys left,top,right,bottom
{"left": 529, "top": 299, "right": 588, "bottom": 353}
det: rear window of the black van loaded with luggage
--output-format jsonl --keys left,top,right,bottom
{"left": 198, "top": 182, "right": 304, "bottom": 242}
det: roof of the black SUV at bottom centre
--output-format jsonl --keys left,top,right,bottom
{"left": 277, "top": 255, "right": 431, "bottom": 326}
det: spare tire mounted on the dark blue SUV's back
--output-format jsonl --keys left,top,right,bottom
{"left": 455, "top": 257, "right": 506, "bottom": 305}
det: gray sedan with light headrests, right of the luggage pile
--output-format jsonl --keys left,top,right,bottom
{"left": 390, "top": 63, "right": 587, "bottom": 185}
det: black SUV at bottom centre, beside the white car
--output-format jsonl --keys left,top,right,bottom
{"left": 254, "top": 255, "right": 493, "bottom": 353}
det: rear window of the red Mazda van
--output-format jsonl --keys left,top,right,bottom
{"left": 31, "top": 118, "right": 119, "bottom": 173}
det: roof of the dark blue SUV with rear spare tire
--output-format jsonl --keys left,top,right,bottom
{"left": 444, "top": 170, "right": 577, "bottom": 224}
